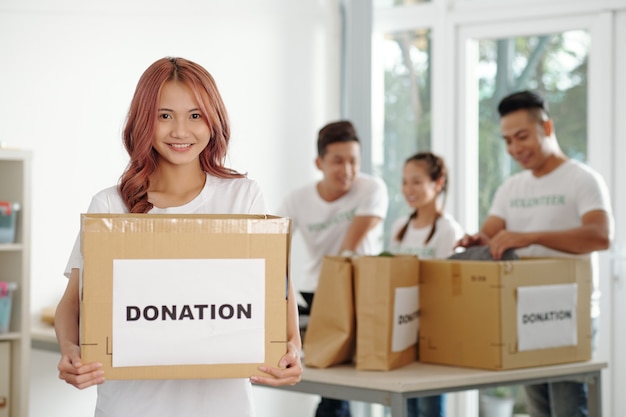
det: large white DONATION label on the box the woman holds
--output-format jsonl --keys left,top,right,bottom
{"left": 112, "top": 259, "right": 265, "bottom": 367}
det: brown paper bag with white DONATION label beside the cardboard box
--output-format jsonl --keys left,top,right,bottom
{"left": 353, "top": 255, "right": 419, "bottom": 371}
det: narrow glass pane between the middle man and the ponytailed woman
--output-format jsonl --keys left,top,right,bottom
{"left": 372, "top": 28, "right": 432, "bottom": 243}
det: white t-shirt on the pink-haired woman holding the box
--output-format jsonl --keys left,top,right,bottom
{"left": 65, "top": 175, "right": 267, "bottom": 417}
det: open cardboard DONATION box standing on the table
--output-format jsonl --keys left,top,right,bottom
{"left": 419, "top": 258, "right": 592, "bottom": 370}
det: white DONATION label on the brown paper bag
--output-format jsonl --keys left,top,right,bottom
{"left": 391, "top": 286, "right": 419, "bottom": 352}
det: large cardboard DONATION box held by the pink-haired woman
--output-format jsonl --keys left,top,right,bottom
{"left": 80, "top": 214, "right": 291, "bottom": 380}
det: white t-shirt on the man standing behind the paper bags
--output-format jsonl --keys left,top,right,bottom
{"left": 277, "top": 173, "right": 389, "bottom": 292}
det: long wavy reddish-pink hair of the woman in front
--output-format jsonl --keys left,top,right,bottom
{"left": 119, "top": 58, "right": 244, "bottom": 213}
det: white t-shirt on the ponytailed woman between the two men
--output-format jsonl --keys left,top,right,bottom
{"left": 389, "top": 213, "right": 465, "bottom": 259}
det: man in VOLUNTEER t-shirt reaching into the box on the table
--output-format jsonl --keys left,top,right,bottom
{"left": 459, "top": 91, "right": 613, "bottom": 417}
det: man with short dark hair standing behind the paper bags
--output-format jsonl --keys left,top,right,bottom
{"left": 278, "top": 120, "right": 388, "bottom": 417}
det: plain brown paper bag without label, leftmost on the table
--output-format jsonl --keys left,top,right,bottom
{"left": 304, "top": 256, "right": 356, "bottom": 368}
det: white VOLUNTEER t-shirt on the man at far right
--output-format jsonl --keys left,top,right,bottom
{"left": 489, "top": 160, "right": 612, "bottom": 317}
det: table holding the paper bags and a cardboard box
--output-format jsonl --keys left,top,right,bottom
{"left": 264, "top": 361, "right": 607, "bottom": 417}
